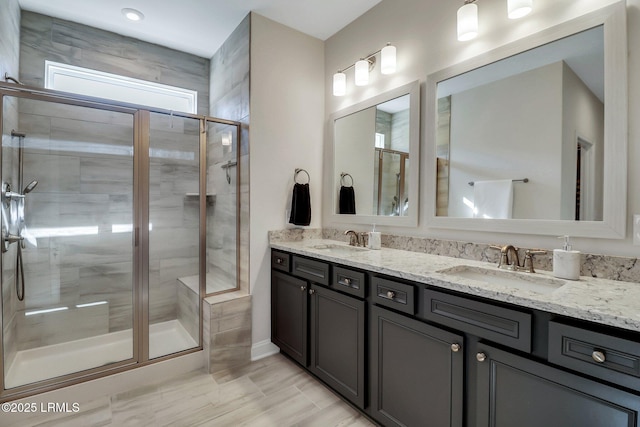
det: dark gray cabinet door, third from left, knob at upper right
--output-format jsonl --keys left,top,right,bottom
{"left": 370, "top": 306, "right": 464, "bottom": 427}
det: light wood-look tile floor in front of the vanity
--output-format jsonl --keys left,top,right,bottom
{"left": 8, "top": 354, "right": 375, "bottom": 427}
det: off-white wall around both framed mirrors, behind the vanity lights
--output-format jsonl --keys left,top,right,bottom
{"left": 324, "top": 0, "right": 640, "bottom": 256}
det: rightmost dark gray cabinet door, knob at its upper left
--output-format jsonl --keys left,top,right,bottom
{"left": 476, "top": 344, "right": 640, "bottom": 427}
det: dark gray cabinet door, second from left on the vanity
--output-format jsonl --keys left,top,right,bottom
{"left": 309, "top": 285, "right": 365, "bottom": 408}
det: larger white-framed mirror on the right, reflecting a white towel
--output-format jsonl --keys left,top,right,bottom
{"left": 427, "top": 2, "right": 627, "bottom": 238}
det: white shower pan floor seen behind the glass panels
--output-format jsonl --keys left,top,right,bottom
{"left": 5, "top": 320, "right": 198, "bottom": 389}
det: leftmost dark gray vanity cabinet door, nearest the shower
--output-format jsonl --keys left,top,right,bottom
{"left": 271, "top": 271, "right": 308, "bottom": 366}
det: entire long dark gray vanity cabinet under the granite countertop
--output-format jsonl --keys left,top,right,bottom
{"left": 272, "top": 252, "right": 640, "bottom": 427}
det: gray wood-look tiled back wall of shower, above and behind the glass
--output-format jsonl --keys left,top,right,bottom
{"left": 10, "top": 12, "right": 209, "bottom": 348}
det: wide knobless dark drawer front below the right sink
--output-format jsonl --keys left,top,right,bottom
{"left": 424, "top": 289, "right": 531, "bottom": 353}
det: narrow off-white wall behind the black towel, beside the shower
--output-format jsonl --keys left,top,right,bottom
{"left": 249, "top": 13, "right": 324, "bottom": 344}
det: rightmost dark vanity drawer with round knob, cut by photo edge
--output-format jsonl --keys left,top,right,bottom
{"left": 549, "top": 322, "right": 640, "bottom": 391}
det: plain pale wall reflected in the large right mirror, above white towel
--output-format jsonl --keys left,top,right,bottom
{"left": 449, "top": 62, "right": 564, "bottom": 219}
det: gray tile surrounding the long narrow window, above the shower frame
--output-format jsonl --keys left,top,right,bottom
{"left": 20, "top": 11, "right": 209, "bottom": 115}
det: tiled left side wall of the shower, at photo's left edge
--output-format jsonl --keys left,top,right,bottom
{"left": 0, "top": 0, "right": 20, "bottom": 380}
